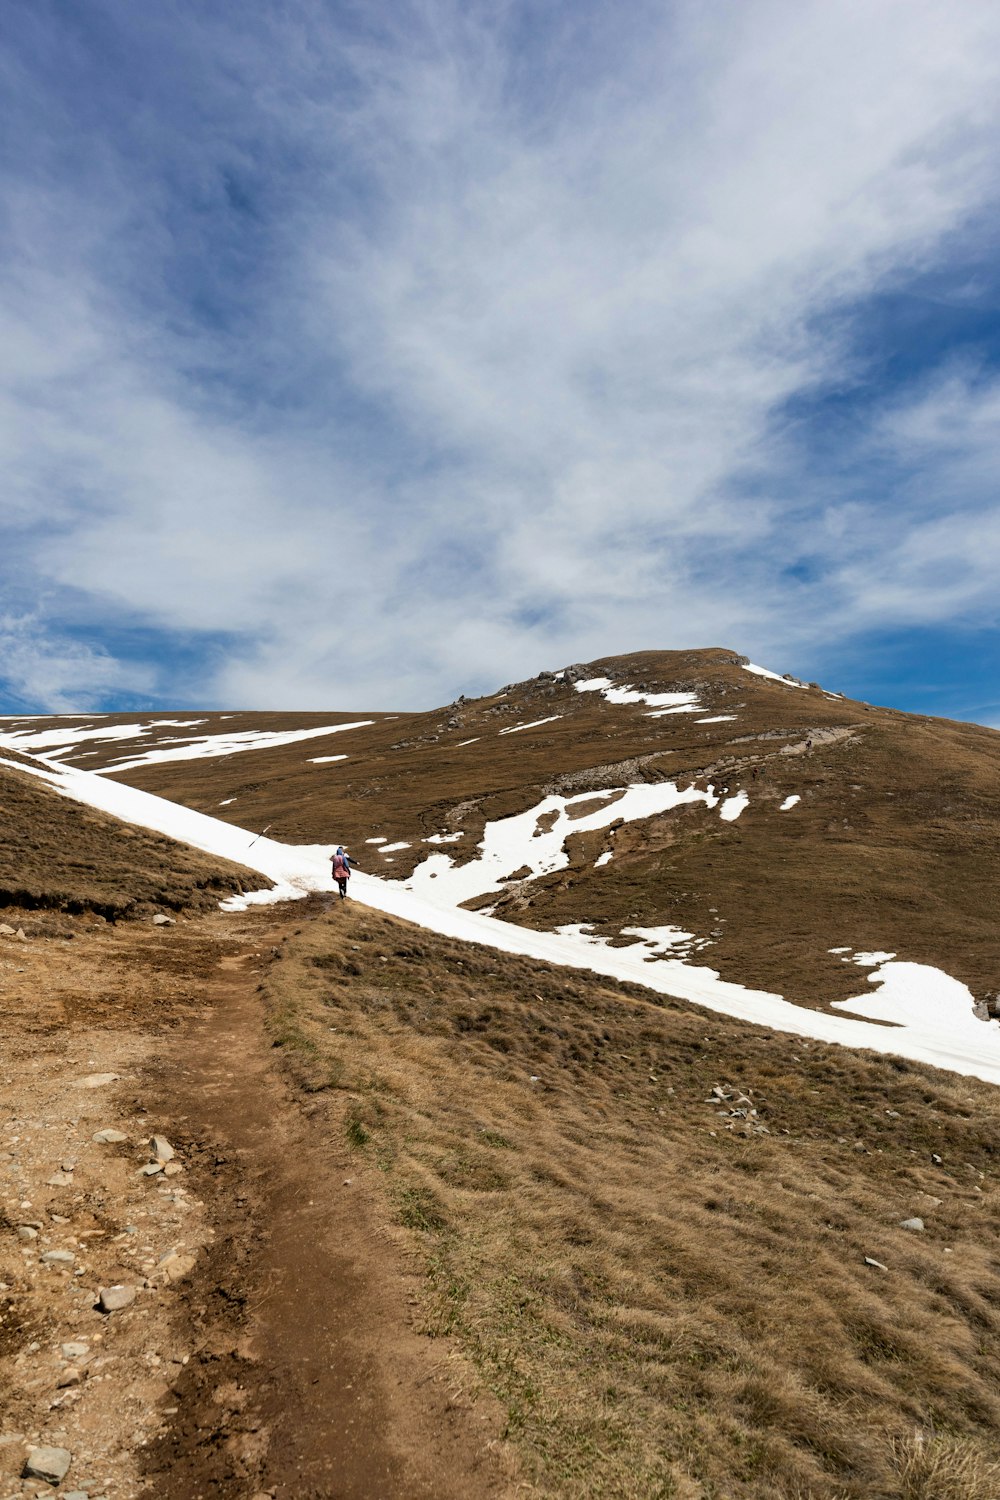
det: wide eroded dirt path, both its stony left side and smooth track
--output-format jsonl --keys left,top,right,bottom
{"left": 0, "top": 903, "right": 508, "bottom": 1500}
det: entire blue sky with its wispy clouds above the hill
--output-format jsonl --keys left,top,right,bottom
{"left": 0, "top": 0, "right": 1000, "bottom": 726}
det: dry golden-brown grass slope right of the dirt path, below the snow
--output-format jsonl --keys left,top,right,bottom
{"left": 267, "top": 903, "right": 1000, "bottom": 1500}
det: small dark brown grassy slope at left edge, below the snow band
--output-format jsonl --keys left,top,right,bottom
{"left": 0, "top": 756, "right": 267, "bottom": 920}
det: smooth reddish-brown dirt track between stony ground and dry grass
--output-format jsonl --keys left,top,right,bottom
{"left": 140, "top": 918, "right": 502, "bottom": 1500}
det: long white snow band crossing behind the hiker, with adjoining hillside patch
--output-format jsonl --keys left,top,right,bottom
{"left": 0, "top": 761, "right": 1000, "bottom": 1083}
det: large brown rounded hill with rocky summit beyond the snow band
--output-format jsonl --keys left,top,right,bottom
{"left": 37, "top": 650, "right": 1000, "bottom": 1007}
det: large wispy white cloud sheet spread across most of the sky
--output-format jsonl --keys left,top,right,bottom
{"left": 0, "top": 0, "right": 1000, "bottom": 707}
